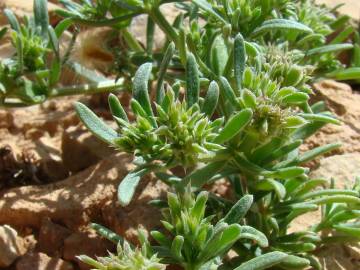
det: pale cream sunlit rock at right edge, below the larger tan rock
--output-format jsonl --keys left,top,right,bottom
{"left": 310, "top": 153, "right": 360, "bottom": 188}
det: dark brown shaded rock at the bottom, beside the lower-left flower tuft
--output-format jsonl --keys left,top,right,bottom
{"left": 63, "top": 232, "right": 115, "bottom": 270}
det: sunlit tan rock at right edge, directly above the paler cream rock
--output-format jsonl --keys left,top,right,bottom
{"left": 306, "top": 80, "right": 360, "bottom": 154}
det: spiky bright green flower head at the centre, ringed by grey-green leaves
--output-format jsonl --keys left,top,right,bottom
{"left": 115, "top": 89, "right": 222, "bottom": 167}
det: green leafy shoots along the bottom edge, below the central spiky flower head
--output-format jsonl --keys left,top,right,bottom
{"left": 79, "top": 190, "right": 308, "bottom": 270}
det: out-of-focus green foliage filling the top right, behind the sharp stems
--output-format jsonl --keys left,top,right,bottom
{"left": 182, "top": 0, "right": 355, "bottom": 78}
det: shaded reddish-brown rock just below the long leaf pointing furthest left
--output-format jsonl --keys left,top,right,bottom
{"left": 61, "top": 126, "right": 115, "bottom": 173}
